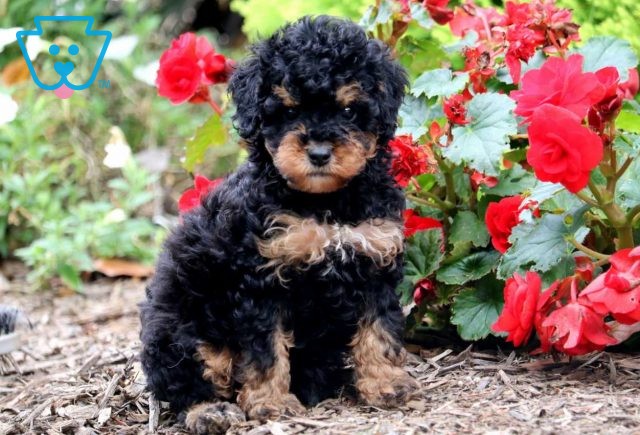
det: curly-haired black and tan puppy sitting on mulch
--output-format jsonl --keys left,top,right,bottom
{"left": 141, "top": 17, "right": 416, "bottom": 432}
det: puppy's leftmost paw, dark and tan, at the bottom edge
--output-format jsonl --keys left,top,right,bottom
{"left": 185, "top": 402, "right": 245, "bottom": 435}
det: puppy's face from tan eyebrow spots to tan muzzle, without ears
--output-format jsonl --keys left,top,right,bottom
{"left": 262, "top": 81, "right": 377, "bottom": 193}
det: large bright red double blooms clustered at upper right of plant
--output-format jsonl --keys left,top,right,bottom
{"left": 511, "top": 54, "right": 637, "bottom": 193}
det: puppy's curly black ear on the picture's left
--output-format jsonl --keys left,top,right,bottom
{"left": 228, "top": 56, "right": 263, "bottom": 142}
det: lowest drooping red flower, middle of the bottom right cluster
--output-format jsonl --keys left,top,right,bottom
{"left": 542, "top": 301, "right": 617, "bottom": 355}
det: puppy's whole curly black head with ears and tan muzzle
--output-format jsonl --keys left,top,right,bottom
{"left": 229, "top": 16, "right": 407, "bottom": 193}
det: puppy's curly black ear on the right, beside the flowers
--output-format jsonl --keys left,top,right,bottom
{"left": 368, "top": 39, "right": 409, "bottom": 140}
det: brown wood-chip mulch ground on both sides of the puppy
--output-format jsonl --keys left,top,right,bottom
{"left": 0, "top": 264, "right": 640, "bottom": 435}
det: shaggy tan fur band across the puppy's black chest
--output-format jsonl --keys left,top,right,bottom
{"left": 257, "top": 214, "right": 404, "bottom": 274}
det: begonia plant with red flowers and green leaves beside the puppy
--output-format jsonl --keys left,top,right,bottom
{"left": 378, "top": 0, "right": 640, "bottom": 355}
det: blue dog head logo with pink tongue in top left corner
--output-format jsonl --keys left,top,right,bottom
{"left": 16, "top": 16, "right": 111, "bottom": 99}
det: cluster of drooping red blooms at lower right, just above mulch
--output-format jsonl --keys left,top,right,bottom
{"left": 492, "top": 247, "right": 640, "bottom": 355}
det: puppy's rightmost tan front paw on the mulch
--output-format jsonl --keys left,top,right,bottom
{"left": 356, "top": 367, "right": 420, "bottom": 408}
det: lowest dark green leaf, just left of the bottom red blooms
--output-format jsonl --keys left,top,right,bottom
{"left": 451, "top": 276, "right": 504, "bottom": 340}
